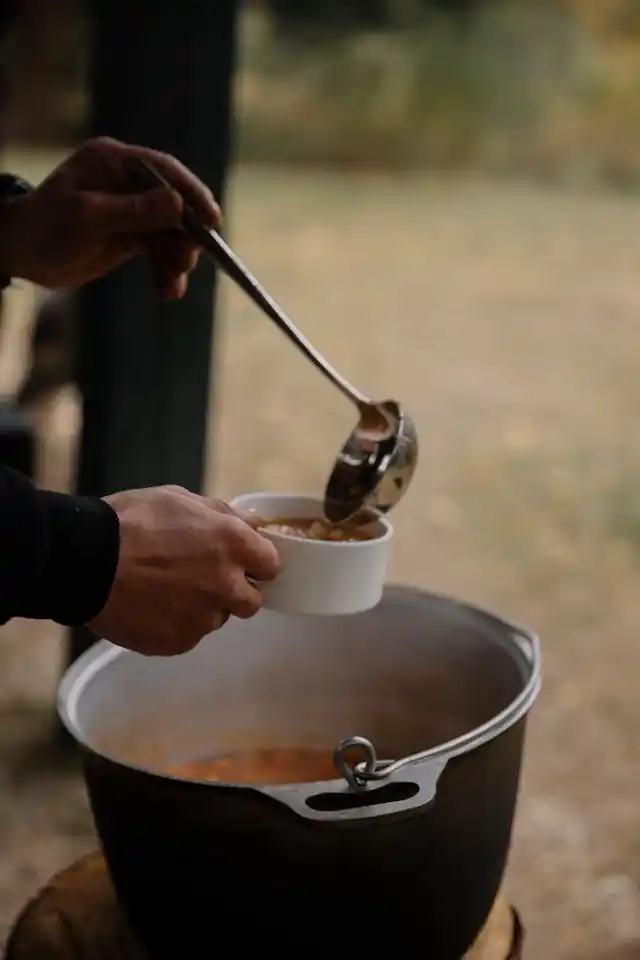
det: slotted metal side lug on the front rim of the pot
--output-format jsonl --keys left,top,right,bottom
{"left": 257, "top": 757, "right": 447, "bottom": 825}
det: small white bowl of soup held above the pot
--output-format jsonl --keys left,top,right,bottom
{"left": 231, "top": 493, "right": 393, "bottom": 615}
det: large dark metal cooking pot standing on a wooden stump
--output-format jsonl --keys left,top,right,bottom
{"left": 60, "top": 588, "right": 540, "bottom": 960}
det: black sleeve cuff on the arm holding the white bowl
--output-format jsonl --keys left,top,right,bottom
{"left": 0, "top": 467, "right": 120, "bottom": 626}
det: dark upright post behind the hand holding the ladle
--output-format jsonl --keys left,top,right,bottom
{"left": 70, "top": 0, "right": 238, "bottom": 659}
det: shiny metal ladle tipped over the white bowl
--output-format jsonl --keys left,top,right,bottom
{"left": 138, "top": 161, "right": 418, "bottom": 523}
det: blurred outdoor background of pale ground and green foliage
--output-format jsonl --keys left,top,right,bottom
{"left": 0, "top": 0, "right": 640, "bottom": 960}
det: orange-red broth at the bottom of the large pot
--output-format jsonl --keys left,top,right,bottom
{"left": 166, "top": 748, "right": 339, "bottom": 786}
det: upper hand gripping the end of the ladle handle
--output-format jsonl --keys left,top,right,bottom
{"left": 0, "top": 137, "right": 220, "bottom": 299}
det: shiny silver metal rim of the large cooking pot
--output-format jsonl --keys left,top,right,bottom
{"left": 57, "top": 586, "right": 542, "bottom": 790}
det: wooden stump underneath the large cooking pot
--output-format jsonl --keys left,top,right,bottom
{"left": 5, "top": 853, "right": 522, "bottom": 960}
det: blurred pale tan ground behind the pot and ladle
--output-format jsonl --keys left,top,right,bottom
{"left": 0, "top": 158, "right": 640, "bottom": 960}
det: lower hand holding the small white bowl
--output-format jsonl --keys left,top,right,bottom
{"left": 88, "top": 487, "right": 278, "bottom": 656}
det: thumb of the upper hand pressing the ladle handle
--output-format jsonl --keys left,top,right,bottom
{"left": 85, "top": 187, "right": 184, "bottom": 233}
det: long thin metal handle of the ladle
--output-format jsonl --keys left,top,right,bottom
{"left": 134, "top": 160, "right": 369, "bottom": 407}
